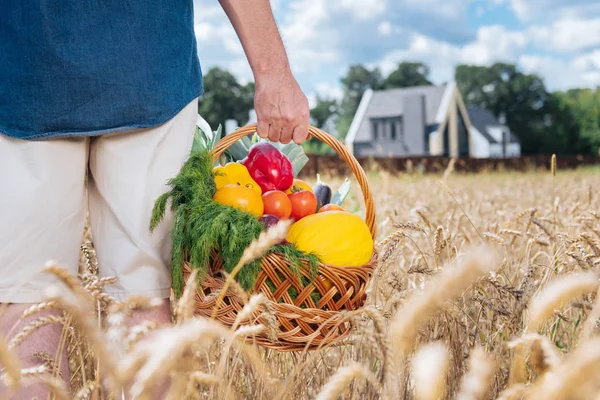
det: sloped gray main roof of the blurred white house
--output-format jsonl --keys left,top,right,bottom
{"left": 368, "top": 86, "right": 446, "bottom": 125}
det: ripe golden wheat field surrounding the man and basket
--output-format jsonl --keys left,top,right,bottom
{"left": 0, "top": 161, "right": 600, "bottom": 400}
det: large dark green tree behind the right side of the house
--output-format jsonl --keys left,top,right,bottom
{"left": 456, "top": 63, "right": 578, "bottom": 154}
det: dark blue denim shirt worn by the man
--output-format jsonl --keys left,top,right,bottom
{"left": 0, "top": 0, "right": 202, "bottom": 139}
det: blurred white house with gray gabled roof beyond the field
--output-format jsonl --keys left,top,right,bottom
{"left": 345, "top": 82, "right": 520, "bottom": 158}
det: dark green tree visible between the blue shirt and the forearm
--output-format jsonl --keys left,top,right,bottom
{"left": 198, "top": 67, "right": 254, "bottom": 133}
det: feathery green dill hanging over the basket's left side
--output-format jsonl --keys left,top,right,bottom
{"left": 150, "top": 147, "right": 318, "bottom": 297}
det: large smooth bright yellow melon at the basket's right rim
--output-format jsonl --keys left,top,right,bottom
{"left": 287, "top": 211, "right": 374, "bottom": 267}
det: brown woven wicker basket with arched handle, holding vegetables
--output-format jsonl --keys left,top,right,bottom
{"left": 184, "top": 124, "right": 377, "bottom": 351}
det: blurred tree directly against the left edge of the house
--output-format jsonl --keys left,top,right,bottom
{"left": 337, "top": 65, "right": 382, "bottom": 137}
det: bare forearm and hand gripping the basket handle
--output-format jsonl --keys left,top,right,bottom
{"left": 219, "top": 0, "right": 309, "bottom": 143}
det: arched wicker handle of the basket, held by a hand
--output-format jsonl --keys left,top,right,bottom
{"left": 211, "top": 124, "right": 376, "bottom": 239}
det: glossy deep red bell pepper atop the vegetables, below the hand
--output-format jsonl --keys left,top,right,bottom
{"left": 242, "top": 142, "right": 294, "bottom": 193}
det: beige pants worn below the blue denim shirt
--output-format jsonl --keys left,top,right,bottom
{"left": 0, "top": 99, "right": 198, "bottom": 303}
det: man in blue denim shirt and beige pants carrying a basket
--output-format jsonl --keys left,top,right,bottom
{"left": 0, "top": 0, "right": 309, "bottom": 398}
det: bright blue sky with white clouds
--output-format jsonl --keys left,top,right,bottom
{"left": 194, "top": 0, "right": 600, "bottom": 104}
